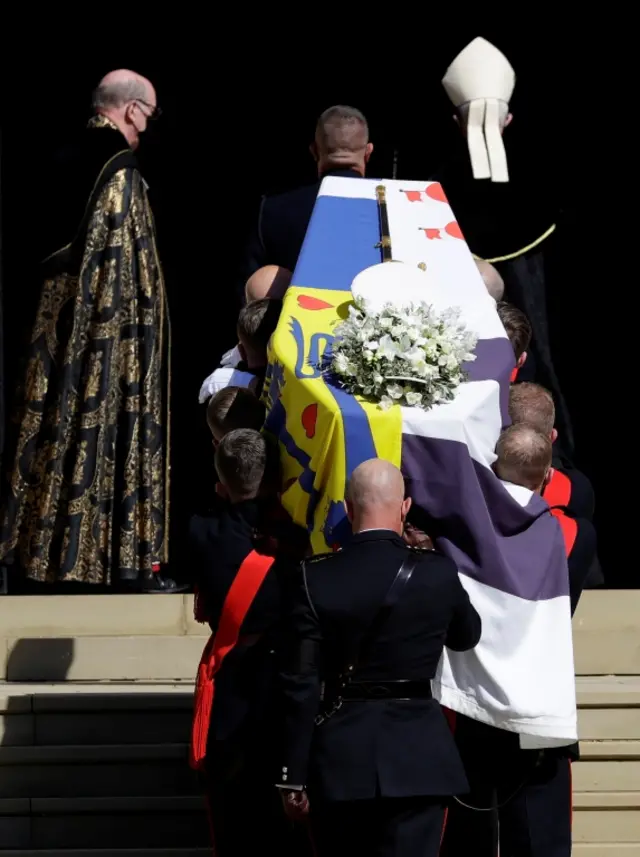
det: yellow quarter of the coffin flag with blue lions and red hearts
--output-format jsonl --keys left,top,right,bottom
{"left": 264, "top": 286, "right": 402, "bottom": 553}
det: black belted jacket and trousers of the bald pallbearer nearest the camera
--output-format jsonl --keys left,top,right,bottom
{"left": 278, "top": 530, "right": 481, "bottom": 857}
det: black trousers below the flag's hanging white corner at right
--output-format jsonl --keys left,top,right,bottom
{"left": 441, "top": 715, "right": 572, "bottom": 857}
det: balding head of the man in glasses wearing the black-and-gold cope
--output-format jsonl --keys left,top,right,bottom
{"left": 91, "top": 68, "right": 157, "bottom": 149}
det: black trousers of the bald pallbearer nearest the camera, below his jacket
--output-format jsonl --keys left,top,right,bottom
{"left": 309, "top": 794, "right": 446, "bottom": 857}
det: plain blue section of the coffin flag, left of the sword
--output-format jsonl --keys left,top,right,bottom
{"left": 293, "top": 195, "right": 382, "bottom": 292}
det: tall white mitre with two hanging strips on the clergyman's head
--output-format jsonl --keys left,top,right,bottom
{"left": 442, "top": 36, "right": 516, "bottom": 182}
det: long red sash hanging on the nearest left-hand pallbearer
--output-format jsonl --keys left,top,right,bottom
{"left": 189, "top": 551, "right": 275, "bottom": 770}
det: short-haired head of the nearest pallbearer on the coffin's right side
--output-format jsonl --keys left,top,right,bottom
{"left": 494, "top": 423, "right": 552, "bottom": 493}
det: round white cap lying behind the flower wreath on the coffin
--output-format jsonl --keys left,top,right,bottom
{"left": 351, "top": 262, "right": 429, "bottom": 312}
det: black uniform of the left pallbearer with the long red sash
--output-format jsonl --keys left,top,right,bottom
{"left": 189, "top": 500, "right": 306, "bottom": 857}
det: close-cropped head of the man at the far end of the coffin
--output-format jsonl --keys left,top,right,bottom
{"left": 311, "top": 104, "right": 373, "bottom": 175}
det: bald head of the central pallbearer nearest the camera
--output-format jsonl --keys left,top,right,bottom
{"left": 346, "top": 458, "right": 411, "bottom": 533}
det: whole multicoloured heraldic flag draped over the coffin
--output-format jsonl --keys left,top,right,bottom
{"left": 265, "top": 177, "right": 577, "bottom": 747}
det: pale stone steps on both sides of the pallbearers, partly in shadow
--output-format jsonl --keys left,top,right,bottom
{"left": 0, "top": 592, "right": 640, "bottom": 857}
